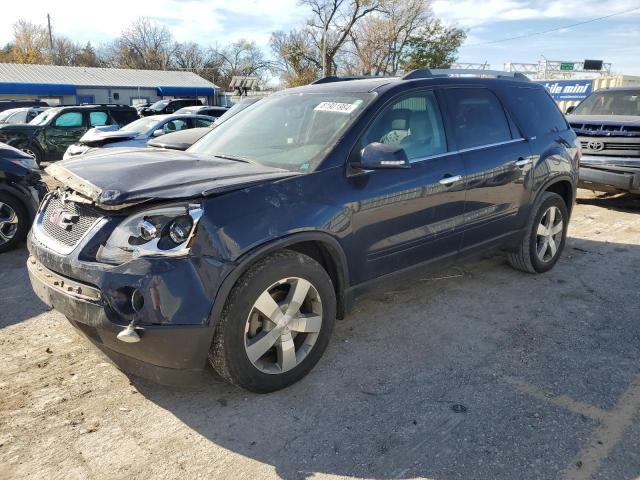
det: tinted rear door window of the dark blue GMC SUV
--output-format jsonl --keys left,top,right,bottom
{"left": 445, "top": 88, "right": 512, "bottom": 149}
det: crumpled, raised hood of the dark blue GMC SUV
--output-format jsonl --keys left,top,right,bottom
{"left": 46, "top": 148, "right": 300, "bottom": 209}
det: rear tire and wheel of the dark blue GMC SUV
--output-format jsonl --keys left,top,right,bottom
{"left": 508, "top": 192, "right": 569, "bottom": 273}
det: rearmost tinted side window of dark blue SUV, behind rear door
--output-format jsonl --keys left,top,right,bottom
{"left": 509, "top": 87, "right": 569, "bottom": 137}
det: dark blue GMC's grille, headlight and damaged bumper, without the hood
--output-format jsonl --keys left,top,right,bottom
{"left": 27, "top": 190, "right": 229, "bottom": 384}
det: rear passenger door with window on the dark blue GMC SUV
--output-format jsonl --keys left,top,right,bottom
{"left": 444, "top": 87, "right": 532, "bottom": 249}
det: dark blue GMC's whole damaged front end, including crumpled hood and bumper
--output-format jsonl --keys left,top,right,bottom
{"left": 28, "top": 149, "right": 302, "bottom": 384}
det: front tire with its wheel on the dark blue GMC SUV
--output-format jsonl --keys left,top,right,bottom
{"left": 209, "top": 250, "right": 336, "bottom": 393}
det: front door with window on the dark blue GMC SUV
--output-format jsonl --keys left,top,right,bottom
{"left": 348, "top": 90, "right": 465, "bottom": 283}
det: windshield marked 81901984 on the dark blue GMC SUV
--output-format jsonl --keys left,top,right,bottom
{"left": 188, "top": 93, "right": 374, "bottom": 172}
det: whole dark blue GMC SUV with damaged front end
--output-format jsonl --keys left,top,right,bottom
{"left": 28, "top": 70, "right": 580, "bottom": 392}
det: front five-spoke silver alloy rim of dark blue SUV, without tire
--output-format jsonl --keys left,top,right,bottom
{"left": 244, "top": 277, "right": 322, "bottom": 374}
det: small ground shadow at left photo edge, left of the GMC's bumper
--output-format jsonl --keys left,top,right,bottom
{"left": 0, "top": 244, "right": 49, "bottom": 328}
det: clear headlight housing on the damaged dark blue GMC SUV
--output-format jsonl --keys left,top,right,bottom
{"left": 96, "top": 203, "right": 202, "bottom": 264}
